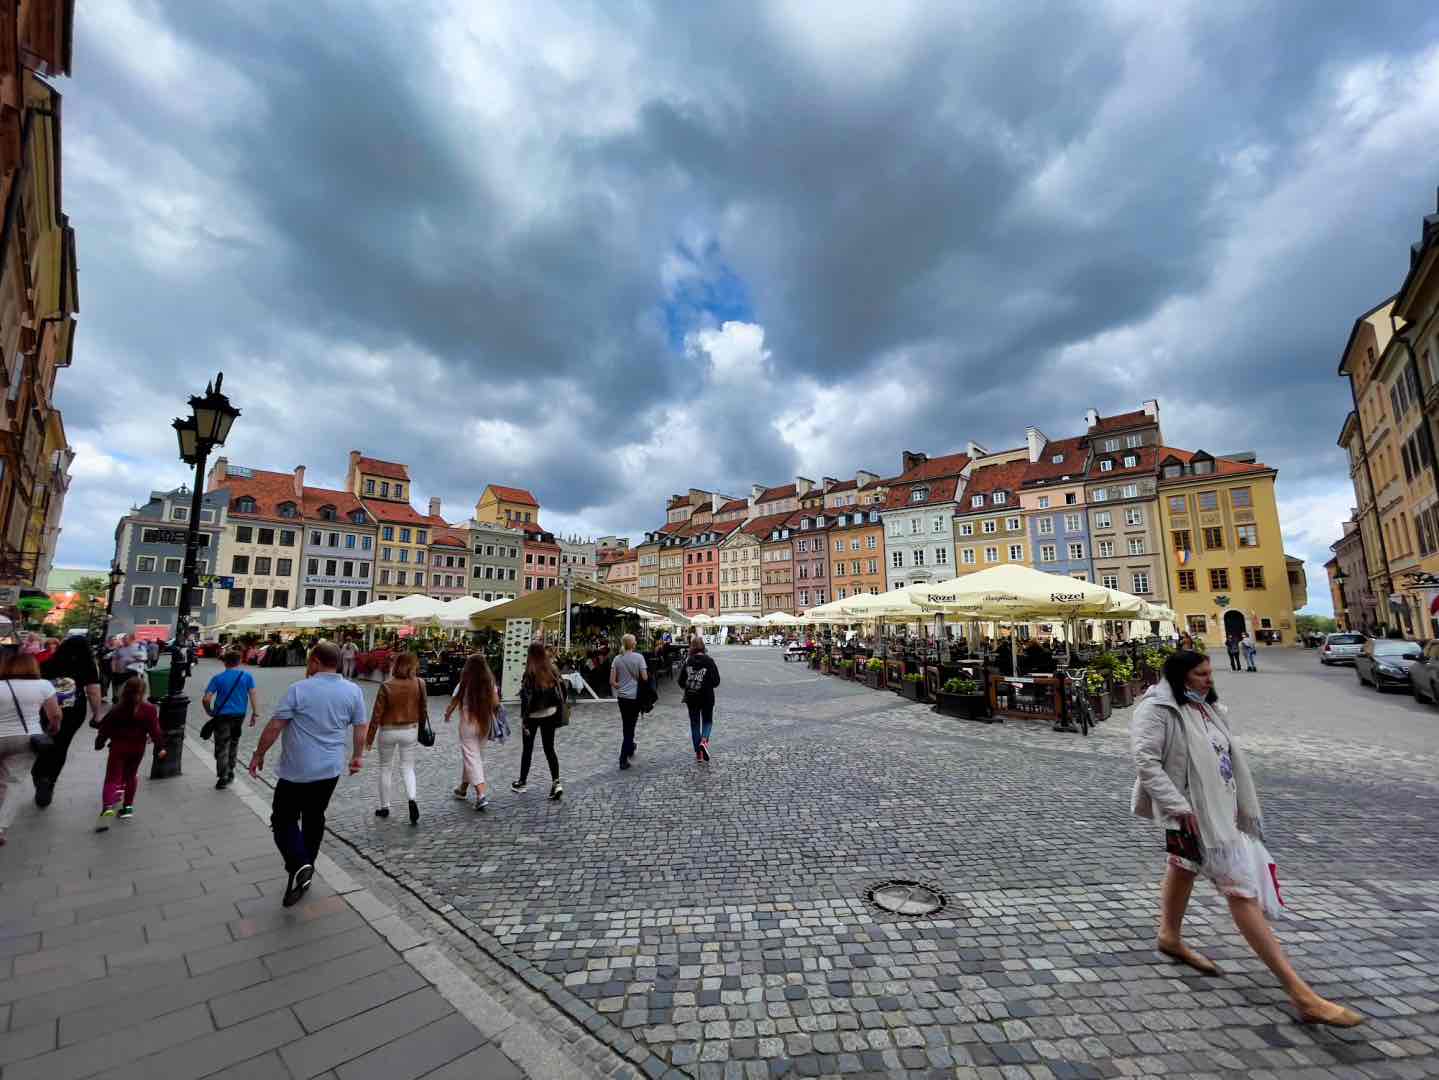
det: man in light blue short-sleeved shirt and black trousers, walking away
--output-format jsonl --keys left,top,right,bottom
{"left": 250, "top": 641, "right": 368, "bottom": 907}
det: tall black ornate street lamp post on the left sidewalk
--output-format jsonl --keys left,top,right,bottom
{"left": 150, "top": 372, "right": 240, "bottom": 779}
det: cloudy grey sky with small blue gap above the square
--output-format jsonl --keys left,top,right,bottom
{"left": 58, "top": 0, "right": 1439, "bottom": 611}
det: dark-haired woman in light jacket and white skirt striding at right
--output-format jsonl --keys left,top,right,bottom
{"left": 1130, "top": 651, "right": 1364, "bottom": 1027}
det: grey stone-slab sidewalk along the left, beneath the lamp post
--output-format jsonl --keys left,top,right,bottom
{"left": 0, "top": 710, "right": 592, "bottom": 1080}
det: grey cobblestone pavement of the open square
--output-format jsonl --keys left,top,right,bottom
{"left": 202, "top": 649, "right": 1439, "bottom": 1080}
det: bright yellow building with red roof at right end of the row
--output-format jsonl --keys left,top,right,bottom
{"left": 1158, "top": 447, "right": 1295, "bottom": 646}
